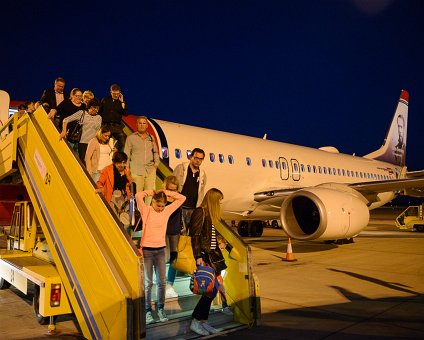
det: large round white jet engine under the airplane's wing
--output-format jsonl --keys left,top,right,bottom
{"left": 280, "top": 187, "right": 370, "bottom": 240}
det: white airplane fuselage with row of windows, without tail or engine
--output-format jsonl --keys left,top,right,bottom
{"left": 150, "top": 120, "right": 400, "bottom": 220}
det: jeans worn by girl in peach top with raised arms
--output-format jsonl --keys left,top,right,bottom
{"left": 143, "top": 248, "right": 166, "bottom": 312}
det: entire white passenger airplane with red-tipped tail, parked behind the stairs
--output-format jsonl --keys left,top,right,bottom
{"left": 126, "top": 90, "right": 424, "bottom": 240}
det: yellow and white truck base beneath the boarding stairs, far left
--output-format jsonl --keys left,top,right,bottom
{"left": 0, "top": 201, "right": 71, "bottom": 329}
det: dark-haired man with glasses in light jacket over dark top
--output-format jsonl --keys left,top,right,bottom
{"left": 174, "top": 148, "right": 206, "bottom": 234}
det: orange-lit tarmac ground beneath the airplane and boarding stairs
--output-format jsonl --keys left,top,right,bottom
{"left": 0, "top": 206, "right": 424, "bottom": 340}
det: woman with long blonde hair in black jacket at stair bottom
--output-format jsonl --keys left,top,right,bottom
{"left": 189, "top": 188, "right": 224, "bottom": 335}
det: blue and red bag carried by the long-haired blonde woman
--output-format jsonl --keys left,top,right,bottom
{"left": 190, "top": 266, "right": 220, "bottom": 299}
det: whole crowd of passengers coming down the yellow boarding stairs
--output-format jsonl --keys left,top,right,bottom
{"left": 13, "top": 77, "right": 233, "bottom": 335}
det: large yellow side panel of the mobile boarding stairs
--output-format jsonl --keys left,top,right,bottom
{"left": 0, "top": 107, "right": 145, "bottom": 339}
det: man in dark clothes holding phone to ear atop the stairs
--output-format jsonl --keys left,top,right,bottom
{"left": 99, "top": 84, "right": 128, "bottom": 151}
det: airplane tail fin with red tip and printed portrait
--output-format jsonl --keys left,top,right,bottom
{"left": 364, "top": 90, "right": 409, "bottom": 166}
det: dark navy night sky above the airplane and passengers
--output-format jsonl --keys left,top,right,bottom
{"left": 0, "top": 0, "right": 424, "bottom": 170}
